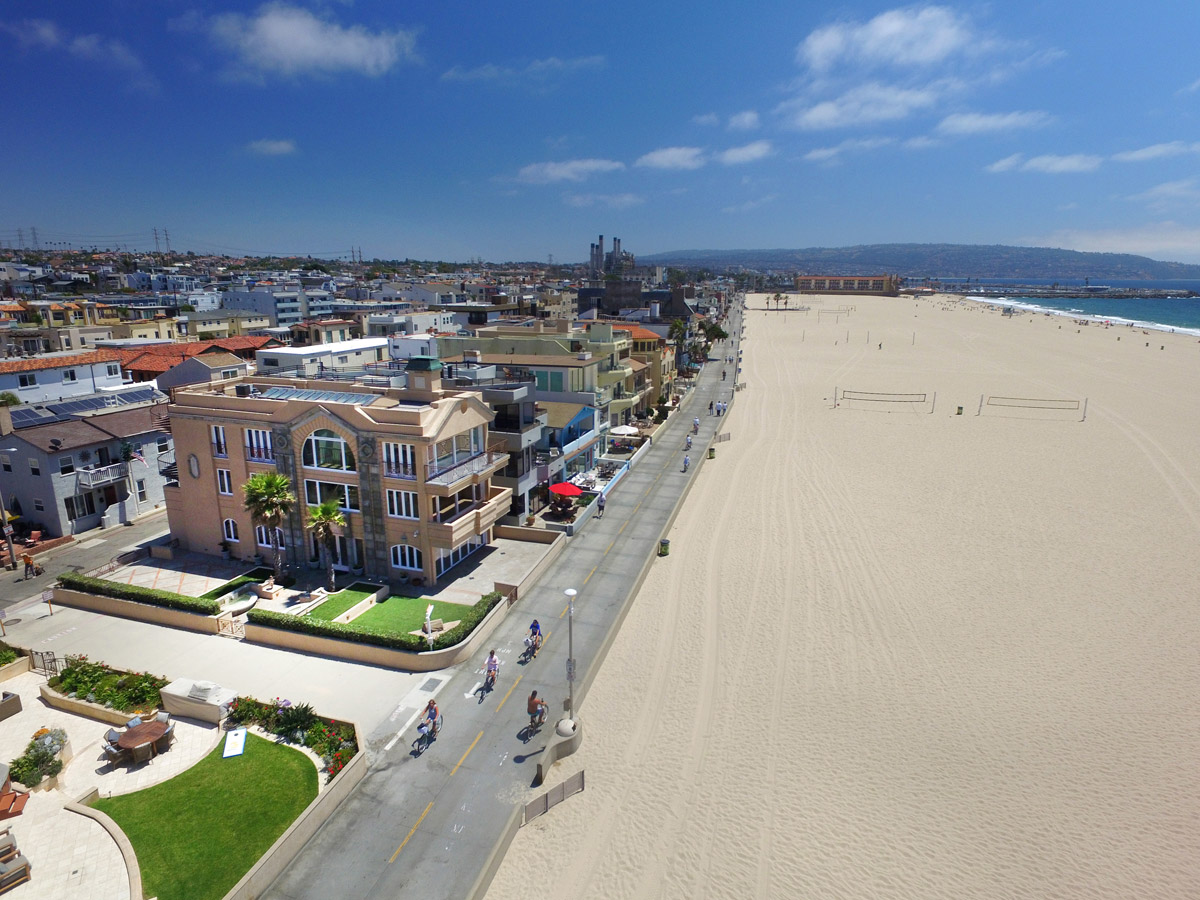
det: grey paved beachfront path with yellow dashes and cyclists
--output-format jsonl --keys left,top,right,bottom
{"left": 265, "top": 304, "right": 740, "bottom": 900}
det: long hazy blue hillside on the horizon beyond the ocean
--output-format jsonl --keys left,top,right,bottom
{"left": 637, "top": 244, "right": 1200, "bottom": 281}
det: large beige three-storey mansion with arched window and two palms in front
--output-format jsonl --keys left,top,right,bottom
{"left": 164, "top": 358, "right": 512, "bottom": 584}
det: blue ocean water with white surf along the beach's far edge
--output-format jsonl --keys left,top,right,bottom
{"left": 968, "top": 280, "right": 1200, "bottom": 335}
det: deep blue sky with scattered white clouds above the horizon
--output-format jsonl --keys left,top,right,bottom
{"left": 0, "top": 0, "right": 1200, "bottom": 262}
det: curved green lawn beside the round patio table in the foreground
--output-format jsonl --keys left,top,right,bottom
{"left": 94, "top": 734, "right": 317, "bottom": 900}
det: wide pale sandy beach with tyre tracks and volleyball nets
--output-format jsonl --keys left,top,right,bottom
{"left": 487, "top": 295, "right": 1200, "bottom": 900}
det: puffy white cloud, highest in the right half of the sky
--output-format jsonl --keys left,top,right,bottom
{"left": 797, "top": 6, "right": 982, "bottom": 72}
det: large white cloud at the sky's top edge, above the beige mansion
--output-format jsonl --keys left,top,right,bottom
{"left": 209, "top": 2, "right": 416, "bottom": 78}
